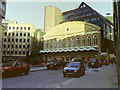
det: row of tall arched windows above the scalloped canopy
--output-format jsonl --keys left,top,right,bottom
{"left": 45, "top": 35, "right": 98, "bottom": 49}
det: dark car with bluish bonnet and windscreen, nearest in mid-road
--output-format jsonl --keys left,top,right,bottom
{"left": 62, "top": 62, "right": 85, "bottom": 77}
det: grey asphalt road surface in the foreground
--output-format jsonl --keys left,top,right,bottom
{"left": 2, "top": 65, "right": 116, "bottom": 88}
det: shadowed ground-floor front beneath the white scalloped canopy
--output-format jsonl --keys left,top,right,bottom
{"left": 41, "top": 51, "right": 98, "bottom": 62}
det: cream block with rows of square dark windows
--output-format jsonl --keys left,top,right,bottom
{"left": 2, "top": 20, "right": 36, "bottom": 60}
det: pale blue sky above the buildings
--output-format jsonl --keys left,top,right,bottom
{"left": 6, "top": 1, "right": 113, "bottom": 29}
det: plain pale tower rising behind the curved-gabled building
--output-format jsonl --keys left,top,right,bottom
{"left": 44, "top": 6, "right": 62, "bottom": 33}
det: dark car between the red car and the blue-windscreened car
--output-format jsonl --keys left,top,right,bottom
{"left": 46, "top": 60, "right": 68, "bottom": 70}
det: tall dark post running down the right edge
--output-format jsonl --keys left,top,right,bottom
{"left": 113, "top": 0, "right": 120, "bottom": 88}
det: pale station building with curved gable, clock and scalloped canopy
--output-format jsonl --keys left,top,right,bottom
{"left": 40, "top": 21, "right": 101, "bottom": 60}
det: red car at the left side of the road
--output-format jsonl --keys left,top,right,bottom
{"left": 0, "top": 61, "right": 30, "bottom": 76}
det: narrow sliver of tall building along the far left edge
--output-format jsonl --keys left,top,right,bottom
{"left": 0, "top": 0, "right": 6, "bottom": 62}
